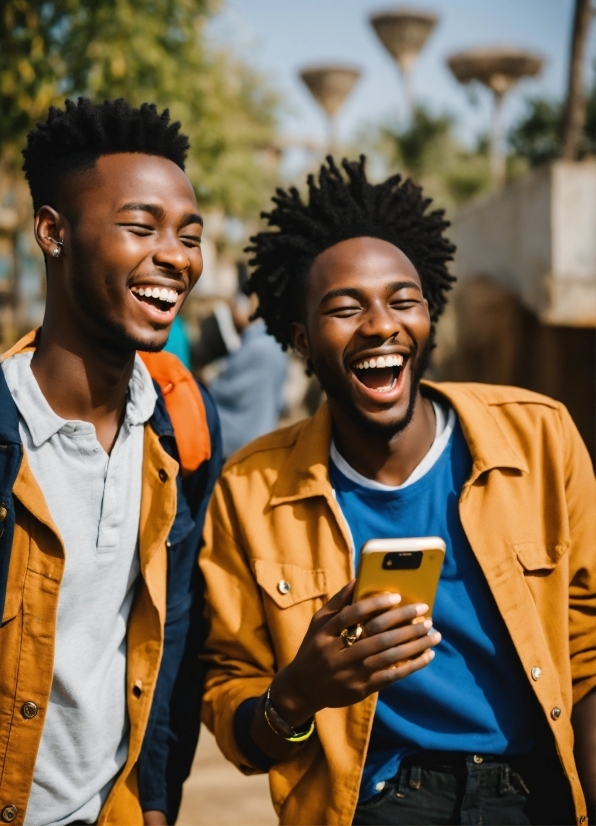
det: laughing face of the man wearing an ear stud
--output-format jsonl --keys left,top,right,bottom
{"left": 36, "top": 153, "right": 203, "bottom": 351}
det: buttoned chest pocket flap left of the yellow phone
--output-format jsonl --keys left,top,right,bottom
{"left": 254, "top": 559, "right": 327, "bottom": 608}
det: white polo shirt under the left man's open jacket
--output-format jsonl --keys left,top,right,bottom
{"left": 2, "top": 353, "right": 157, "bottom": 826}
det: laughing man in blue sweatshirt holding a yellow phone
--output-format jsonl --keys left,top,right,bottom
{"left": 200, "top": 158, "right": 596, "bottom": 826}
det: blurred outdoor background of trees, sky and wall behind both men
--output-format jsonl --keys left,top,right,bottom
{"left": 0, "top": 0, "right": 596, "bottom": 824}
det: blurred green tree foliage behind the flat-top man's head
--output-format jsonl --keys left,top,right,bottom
{"left": 0, "top": 0, "right": 277, "bottom": 216}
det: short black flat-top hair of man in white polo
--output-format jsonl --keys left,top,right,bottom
{"left": 23, "top": 97, "right": 189, "bottom": 212}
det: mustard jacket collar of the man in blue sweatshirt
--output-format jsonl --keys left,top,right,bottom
{"left": 270, "top": 381, "right": 529, "bottom": 506}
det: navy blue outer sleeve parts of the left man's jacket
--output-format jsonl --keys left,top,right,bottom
{"left": 0, "top": 368, "right": 222, "bottom": 823}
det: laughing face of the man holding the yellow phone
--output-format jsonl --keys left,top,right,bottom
{"left": 292, "top": 238, "right": 431, "bottom": 437}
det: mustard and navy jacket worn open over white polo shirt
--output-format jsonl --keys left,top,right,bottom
{"left": 0, "top": 333, "right": 221, "bottom": 826}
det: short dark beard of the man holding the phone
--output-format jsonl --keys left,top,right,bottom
{"left": 317, "top": 336, "right": 434, "bottom": 440}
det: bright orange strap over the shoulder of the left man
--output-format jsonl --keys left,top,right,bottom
{"left": 139, "top": 352, "right": 211, "bottom": 476}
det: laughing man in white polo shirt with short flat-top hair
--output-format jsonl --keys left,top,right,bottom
{"left": 0, "top": 98, "right": 221, "bottom": 826}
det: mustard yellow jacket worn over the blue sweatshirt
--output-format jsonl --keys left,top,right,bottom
{"left": 200, "top": 383, "right": 596, "bottom": 824}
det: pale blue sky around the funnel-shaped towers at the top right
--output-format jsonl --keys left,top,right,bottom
{"left": 210, "top": 0, "right": 596, "bottom": 151}
